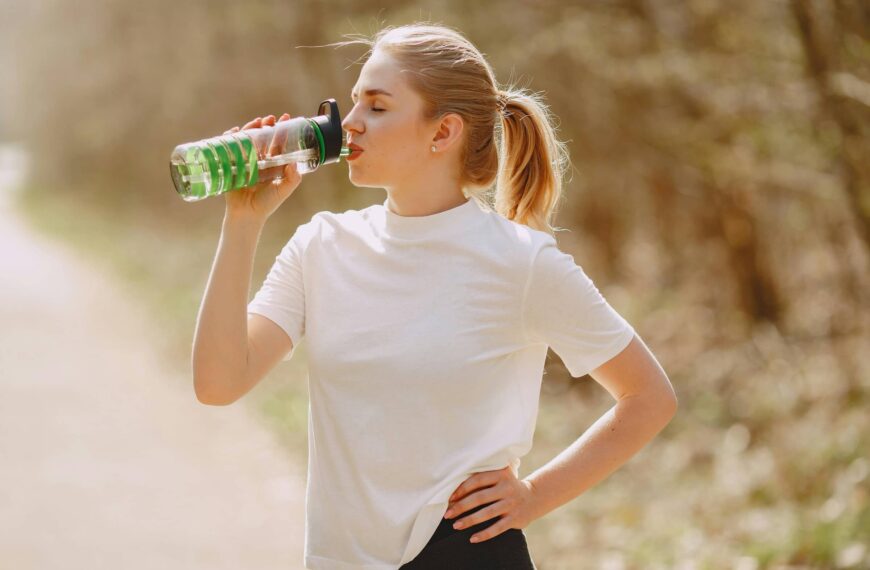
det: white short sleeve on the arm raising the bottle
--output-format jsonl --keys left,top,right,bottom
{"left": 248, "top": 217, "right": 313, "bottom": 361}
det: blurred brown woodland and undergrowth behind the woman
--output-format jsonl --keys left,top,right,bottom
{"left": 0, "top": 0, "right": 870, "bottom": 570}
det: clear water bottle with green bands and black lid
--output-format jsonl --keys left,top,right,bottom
{"left": 169, "top": 99, "right": 350, "bottom": 202}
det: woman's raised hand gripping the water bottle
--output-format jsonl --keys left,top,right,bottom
{"left": 224, "top": 113, "right": 302, "bottom": 222}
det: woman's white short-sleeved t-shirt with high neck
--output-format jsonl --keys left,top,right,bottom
{"left": 248, "top": 198, "right": 634, "bottom": 570}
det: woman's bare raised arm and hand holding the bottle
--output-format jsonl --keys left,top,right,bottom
{"left": 191, "top": 113, "right": 301, "bottom": 405}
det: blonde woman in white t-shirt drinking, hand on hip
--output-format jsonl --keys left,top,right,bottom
{"left": 193, "top": 23, "right": 676, "bottom": 570}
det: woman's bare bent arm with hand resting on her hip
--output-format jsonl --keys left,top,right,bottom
{"left": 447, "top": 335, "right": 677, "bottom": 542}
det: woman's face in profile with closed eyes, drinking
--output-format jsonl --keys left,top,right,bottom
{"left": 342, "top": 50, "right": 464, "bottom": 189}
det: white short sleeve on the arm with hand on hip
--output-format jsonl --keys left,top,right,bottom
{"left": 523, "top": 236, "right": 635, "bottom": 378}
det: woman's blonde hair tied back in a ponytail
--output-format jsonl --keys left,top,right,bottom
{"left": 329, "top": 22, "right": 570, "bottom": 235}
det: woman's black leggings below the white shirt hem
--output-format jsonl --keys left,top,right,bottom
{"left": 399, "top": 503, "right": 536, "bottom": 570}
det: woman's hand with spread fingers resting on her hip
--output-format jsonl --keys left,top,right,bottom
{"left": 445, "top": 465, "right": 537, "bottom": 542}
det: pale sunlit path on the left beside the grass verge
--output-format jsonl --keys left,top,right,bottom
{"left": 0, "top": 148, "right": 305, "bottom": 570}
